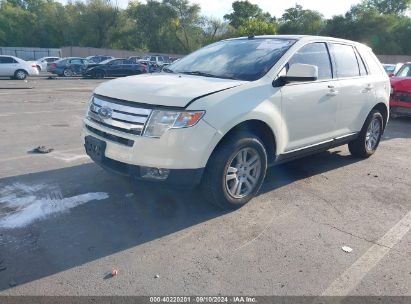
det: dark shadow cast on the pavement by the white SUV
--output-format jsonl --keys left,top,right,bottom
{"left": 0, "top": 150, "right": 364, "bottom": 290}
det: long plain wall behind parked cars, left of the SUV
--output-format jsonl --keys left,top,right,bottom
{"left": 61, "top": 46, "right": 183, "bottom": 58}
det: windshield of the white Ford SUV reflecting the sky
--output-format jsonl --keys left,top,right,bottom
{"left": 165, "top": 38, "right": 295, "bottom": 81}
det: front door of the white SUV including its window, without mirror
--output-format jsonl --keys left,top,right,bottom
{"left": 281, "top": 42, "right": 338, "bottom": 153}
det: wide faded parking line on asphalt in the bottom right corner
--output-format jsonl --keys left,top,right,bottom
{"left": 322, "top": 211, "right": 411, "bottom": 296}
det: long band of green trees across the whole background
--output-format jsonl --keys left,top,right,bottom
{"left": 0, "top": 0, "right": 411, "bottom": 55}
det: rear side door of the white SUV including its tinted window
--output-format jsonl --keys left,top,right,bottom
{"left": 330, "top": 43, "right": 375, "bottom": 137}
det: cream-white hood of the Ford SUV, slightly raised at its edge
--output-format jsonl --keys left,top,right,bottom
{"left": 94, "top": 73, "right": 247, "bottom": 107}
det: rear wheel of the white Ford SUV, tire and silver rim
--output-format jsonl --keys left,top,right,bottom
{"left": 348, "top": 110, "right": 384, "bottom": 158}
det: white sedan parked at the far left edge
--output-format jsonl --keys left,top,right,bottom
{"left": 0, "top": 55, "right": 39, "bottom": 80}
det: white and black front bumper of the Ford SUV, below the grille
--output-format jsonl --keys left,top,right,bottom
{"left": 82, "top": 118, "right": 221, "bottom": 184}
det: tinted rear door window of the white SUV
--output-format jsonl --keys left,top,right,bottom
{"left": 331, "top": 43, "right": 360, "bottom": 78}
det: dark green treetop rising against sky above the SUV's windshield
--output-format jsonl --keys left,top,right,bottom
{"left": 224, "top": 0, "right": 275, "bottom": 28}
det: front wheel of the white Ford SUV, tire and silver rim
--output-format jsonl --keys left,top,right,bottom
{"left": 202, "top": 132, "right": 267, "bottom": 209}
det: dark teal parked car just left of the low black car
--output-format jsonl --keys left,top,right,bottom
{"left": 47, "top": 57, "right": 89, "bottom": 77}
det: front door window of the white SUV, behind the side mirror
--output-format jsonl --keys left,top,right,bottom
{"left": 288, "top": 43, "right": 332, "bottom": 79}
